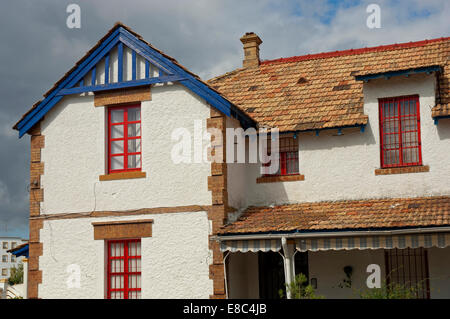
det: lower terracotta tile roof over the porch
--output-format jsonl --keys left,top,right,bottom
{"left": 219, "top": 196, "right": 450, "bottom": 235}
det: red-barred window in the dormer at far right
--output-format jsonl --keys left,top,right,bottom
{"left": 379, "top": 95, "right": 422, "bottom": 168}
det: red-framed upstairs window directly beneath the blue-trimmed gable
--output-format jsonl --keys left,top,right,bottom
{"left": 108, "top": 104, "right": 142, "bottom": 173}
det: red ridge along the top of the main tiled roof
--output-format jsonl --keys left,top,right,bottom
{"left": 261, "top": 37, "right": 450, "bottom": 65}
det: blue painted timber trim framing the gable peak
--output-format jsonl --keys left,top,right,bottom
{"left": 17, "top": 27, "right": 256, "bottom": 137}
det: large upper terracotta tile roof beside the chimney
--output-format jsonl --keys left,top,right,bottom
{"left": 208, "top": 37, "right": 450, "bottom": 131}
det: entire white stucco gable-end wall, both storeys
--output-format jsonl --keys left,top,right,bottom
{"left": 39, "top": 85, "right": 213, "bottom": 298}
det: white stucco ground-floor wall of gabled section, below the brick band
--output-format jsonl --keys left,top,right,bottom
{"left": 39, "top": 212, "right": 213, "bottom": 299}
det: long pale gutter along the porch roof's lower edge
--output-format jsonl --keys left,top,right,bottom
{"left": 211, "top": 226, "right": 450, "bottom": 241}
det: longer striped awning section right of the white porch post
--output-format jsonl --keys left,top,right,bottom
{"left": 295, "top": 233, "right": 450, "bottom": 251}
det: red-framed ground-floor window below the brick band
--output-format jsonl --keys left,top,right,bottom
{"left": 107, "top": 239, "right": 141, "bottom": 299}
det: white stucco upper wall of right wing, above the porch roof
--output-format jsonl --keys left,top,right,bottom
{"left": 239, "top": 75, "right": 450, "bottom": 208}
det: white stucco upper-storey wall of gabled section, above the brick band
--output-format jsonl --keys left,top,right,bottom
{"left": 41, "top": 85, "right": 211, "bottom": 214}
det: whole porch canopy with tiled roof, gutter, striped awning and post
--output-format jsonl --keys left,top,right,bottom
{"left": 216, "top": 196, "right": 450, "bottom": 297}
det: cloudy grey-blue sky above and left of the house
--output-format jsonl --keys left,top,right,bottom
{"left": 0, "top": 0, "right": 450, "bottom": 237}
